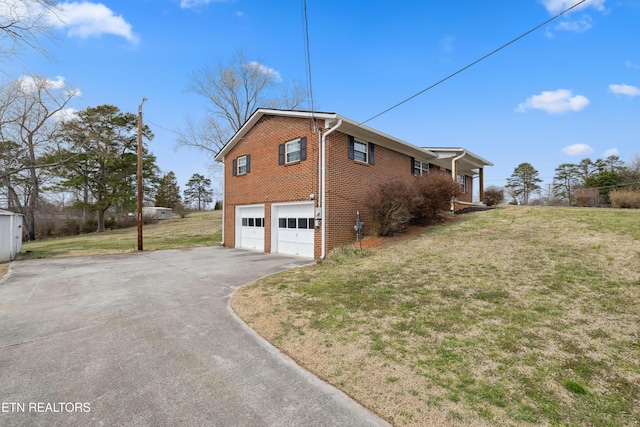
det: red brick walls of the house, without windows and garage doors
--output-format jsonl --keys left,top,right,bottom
{"left": 223, "top": 116, "right": 471, "bottom": 258}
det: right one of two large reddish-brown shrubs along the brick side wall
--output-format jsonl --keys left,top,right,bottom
{"left": 413, "top": 172, "right": 461, "bottom": 222}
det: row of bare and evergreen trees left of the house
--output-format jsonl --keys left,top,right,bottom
{"left": 0, "top": 77, "right": 213, "bottom": 240}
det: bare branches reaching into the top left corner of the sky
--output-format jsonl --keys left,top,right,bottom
{"left": 0, "top": 0, "right": 59, "bottom": 60}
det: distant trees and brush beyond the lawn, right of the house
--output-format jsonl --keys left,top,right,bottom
{"left": 505, "top": 154, "right": 640, "bottom": 206}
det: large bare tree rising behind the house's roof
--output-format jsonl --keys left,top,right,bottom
{"left": 178, "top": 50, "right": 306, "bottom": 159}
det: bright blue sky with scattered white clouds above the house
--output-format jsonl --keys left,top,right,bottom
{"left": 0, "top": 0, "right": 640, "bottom": 201}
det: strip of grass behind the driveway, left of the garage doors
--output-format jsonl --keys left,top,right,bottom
{"left": 22, "top": 211, "right": 222, "bottom": 258}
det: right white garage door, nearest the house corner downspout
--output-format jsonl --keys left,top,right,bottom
{"left": 276, "top": 203, "right": 314, "bottom": 258}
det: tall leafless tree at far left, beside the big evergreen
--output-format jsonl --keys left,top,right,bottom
{"left": 0, "top": 76, "right": 77, "bottom": 240}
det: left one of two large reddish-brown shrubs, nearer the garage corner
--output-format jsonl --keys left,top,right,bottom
{"left": 366, "top": 179, "right": 413, "bottom": 236}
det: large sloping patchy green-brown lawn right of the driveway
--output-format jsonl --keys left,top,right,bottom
{"left": 232, "top": 207, "right": 640, "bottom": 426}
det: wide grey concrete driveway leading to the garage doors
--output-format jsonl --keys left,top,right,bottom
{"left": 0, "top": 247, "right": 387, "bottom": 426}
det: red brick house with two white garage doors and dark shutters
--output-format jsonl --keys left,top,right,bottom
{"left": 215, "top": 109, "right": 493, "bottom": 259}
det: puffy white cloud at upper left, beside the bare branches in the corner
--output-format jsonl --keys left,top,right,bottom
{"left": 50, "top": 1, "right": 138, "bottom": 43}
